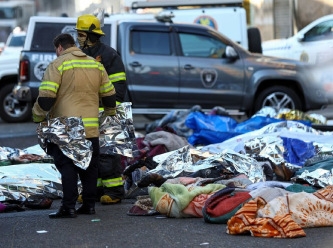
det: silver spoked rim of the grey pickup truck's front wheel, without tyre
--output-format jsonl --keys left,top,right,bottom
{"left": 262, "top": 92, "right": 295, "bottom": 109}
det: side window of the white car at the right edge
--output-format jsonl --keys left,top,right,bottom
{"left": 304, "top": 21, "right": 333, "bottom": 41}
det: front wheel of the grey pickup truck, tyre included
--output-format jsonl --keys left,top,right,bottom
{"left": 254, "top": 86, "right": 302, "bottom": 112}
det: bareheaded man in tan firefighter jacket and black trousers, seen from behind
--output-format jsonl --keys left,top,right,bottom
{"left": 32, "top": 33, "right": 116, "bottom": 218}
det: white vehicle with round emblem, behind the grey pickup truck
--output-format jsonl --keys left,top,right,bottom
{"left": 132, "top": 0, "right": 262, "bottom": 53}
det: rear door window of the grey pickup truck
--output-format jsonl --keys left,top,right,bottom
{"left": 131, "top": 31, "right": 171, "bottom": 55}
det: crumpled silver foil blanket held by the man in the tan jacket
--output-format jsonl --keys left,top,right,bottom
{"left": 37, "top": 117, "right": 92, "bottom": 170}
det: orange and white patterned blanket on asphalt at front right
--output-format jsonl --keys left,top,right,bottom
{"left": 227, "top": 186, "right": 333, "bottom": 238}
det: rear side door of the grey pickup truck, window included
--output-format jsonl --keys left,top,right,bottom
{"left": 122, "top": 24, "right": 179, "bottom": 109}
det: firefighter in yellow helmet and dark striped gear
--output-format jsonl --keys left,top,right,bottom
{"left": 76, "top": 14, "right": 127, "bottom": 204}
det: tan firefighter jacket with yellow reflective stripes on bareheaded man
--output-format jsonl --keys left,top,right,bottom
{"left": 32, "top": 47, "right": 116, "bottom": 138}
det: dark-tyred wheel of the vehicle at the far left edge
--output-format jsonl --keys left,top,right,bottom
{"left": 0, "top": 84, "right": 31, "bottom": 122}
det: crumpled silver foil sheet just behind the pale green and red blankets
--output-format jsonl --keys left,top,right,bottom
{"left": 148, "top": 146, "right": 265, "bottom": 183}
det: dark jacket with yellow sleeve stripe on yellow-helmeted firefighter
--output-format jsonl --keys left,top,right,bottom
{"left": 83, "top": 41, "right": 127, "bottom": 103}
